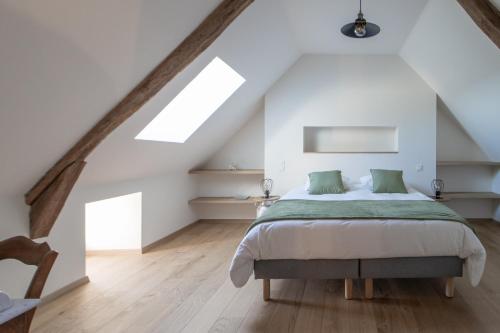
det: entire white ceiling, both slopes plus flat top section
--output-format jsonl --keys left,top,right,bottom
{"left": 0, "top": 0, "right": 500, "bottom": 196}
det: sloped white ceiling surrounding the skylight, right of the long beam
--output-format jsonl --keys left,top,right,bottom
{"left": 82, "top": 1, "right": 300, "bottom": 184}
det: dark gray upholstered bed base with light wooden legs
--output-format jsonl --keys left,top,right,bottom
{"left": 254, "top": 256, "right": 463, "bottom": 301}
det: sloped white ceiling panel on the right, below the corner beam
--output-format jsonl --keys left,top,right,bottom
{"left": 401, "top": 0, "right": 500, "bottom": 160}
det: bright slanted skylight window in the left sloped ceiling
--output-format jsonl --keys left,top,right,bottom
{"left": 135, "top": 57, "right": 245, "bottom": 143}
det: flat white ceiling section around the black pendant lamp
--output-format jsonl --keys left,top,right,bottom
{"left": 279, "top": 0, "right": 428, "bottom": 54}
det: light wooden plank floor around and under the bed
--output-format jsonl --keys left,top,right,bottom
{"left": 32, "top": 221, "right": 500, "bottom": 333}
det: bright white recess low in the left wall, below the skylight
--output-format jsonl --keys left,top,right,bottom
{"left": 85, "top": 192, "right": 142, "bottom": 251}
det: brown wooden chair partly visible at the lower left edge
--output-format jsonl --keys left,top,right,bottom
{"left": 0, "top": 236, "right": 58, "bottom": 333}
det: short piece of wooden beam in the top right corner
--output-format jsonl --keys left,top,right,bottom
{"left": 457, "top": 0, "right": 500, "bottom": 49}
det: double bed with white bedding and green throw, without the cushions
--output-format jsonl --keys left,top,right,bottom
{"left": 230, "top": 187, "right": 486, "bottom": 300}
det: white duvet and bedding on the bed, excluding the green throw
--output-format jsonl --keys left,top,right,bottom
{"left": 230, "top": 188, "right": 486, "bottom": 287}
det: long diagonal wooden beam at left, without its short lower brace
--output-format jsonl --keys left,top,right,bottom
{"left": 25, "top": 0, "right": 253, "bottom": 205}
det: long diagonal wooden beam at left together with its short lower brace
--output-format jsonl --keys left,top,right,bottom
{"left": 25, "top": 0, "right": 254, "bottom": 238}
